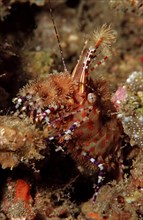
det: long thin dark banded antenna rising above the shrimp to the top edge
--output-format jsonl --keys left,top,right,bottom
{"left": 49, "top": 0, "right": 67, "bottom": 72}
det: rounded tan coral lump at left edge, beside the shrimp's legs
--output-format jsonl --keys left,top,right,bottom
{"left": 0, "top": 116, "right": 46, "bottom": 169}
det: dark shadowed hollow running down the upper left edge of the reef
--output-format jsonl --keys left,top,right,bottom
{"left": 0, "top": 3, "right": 39, "bottom": 109}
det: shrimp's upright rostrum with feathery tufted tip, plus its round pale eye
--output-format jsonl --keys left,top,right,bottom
{"left": 72, "top": 24, "right": 116, "bottom": 104}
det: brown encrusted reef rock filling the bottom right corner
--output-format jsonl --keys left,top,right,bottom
{"left": 81, "top": 150, "right": 143, "bottom": 220}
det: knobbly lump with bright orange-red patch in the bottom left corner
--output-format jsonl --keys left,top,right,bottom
{"left": 1, "top": 179, "right": 35, "bottom": 220}
